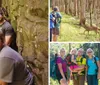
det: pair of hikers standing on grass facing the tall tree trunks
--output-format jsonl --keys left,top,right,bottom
{"left": 50, "top": 6, "right": 62, "bottom": 42}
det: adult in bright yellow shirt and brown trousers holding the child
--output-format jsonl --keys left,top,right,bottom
{"left": 72, "top": 48, "right": 86, "bottom": 85}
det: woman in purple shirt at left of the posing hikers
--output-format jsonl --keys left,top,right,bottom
{"left": 56, "top": 48, "right": 67, "bottom": 85}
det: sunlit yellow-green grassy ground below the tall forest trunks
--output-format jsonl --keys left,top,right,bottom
{"left": 58, "top": 13, "right": 100, "bottom": 42}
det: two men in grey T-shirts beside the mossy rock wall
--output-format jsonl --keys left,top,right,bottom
{"left": 0, "top": 7, "right": 33, "bottom": 85}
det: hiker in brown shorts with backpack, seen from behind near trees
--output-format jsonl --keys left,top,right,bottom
{"left": 52, "top": 6, "right": 62, "bottom": 41}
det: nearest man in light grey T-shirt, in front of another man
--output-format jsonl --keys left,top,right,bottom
{"left": 0, "top": 32, "right": 33, "bottom": 85}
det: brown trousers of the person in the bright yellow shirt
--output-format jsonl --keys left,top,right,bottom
{"left": 73, "top": 75, "right": 85, "bottom": 85}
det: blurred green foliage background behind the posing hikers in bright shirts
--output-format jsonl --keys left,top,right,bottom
{"left": 50, "top": 43, "right": 100, "bottom": 85}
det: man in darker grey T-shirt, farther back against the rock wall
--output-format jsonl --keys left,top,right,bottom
{"left": 0, "top": 8, "right": 18, "bottom": 51}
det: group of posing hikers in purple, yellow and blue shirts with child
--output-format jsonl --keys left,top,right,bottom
{"left": 52, "top": 48, "right": 100, "bottom": 85}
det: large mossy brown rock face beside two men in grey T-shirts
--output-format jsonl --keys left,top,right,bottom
{"left": 2, "top": 0, "right": 48, "bottom": 85}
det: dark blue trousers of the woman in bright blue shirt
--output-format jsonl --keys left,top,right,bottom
{"left": 87, "top": 75, "right": 98, "bottom": 85}
